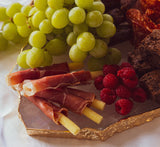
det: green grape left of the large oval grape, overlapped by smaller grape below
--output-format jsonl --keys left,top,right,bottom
{"left": 32, "top": 11, "right": 46, "bottom": 28}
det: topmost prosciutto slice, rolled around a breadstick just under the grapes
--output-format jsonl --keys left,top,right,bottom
{"left": 8, "top": 63, "right": 70, "bottom": 86}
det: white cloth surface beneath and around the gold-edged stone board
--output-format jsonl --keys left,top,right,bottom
{"left": 0, "top": 0, "right": 160, "bottom": 147}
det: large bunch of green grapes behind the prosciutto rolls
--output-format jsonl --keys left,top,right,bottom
{"left": 0, "top": 0, "right": 121, "bottom": 70}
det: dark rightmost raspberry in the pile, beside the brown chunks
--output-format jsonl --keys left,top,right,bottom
{"left": 132, "top": 87, "right": 147, "bottom": 103}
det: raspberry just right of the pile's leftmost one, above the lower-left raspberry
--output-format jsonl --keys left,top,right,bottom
{"left": 103, "top": 74, "right": 119, "bottom": 89}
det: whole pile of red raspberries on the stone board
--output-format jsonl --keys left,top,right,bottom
{"left": 94, "top": 62, "right": 147, "bottom": 115}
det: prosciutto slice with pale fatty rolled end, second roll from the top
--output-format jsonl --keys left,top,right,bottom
{"left": 22, "top": 70, "right": 92, "bottom": 96}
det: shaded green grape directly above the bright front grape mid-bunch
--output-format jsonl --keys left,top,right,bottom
{"left": 73, "top": 23, "right": 88, "bottom": 34}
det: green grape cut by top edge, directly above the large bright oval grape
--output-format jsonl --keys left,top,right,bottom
{"left": 48, "top": 0, "right": 64, "bottom": 9}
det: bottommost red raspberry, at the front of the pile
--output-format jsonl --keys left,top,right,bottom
{"left": 115, "top": 99, "right": 133, "bottom": 115}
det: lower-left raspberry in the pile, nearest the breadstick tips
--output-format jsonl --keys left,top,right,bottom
{"left": 100, "top": 88, "right": 117, "bottom": 105}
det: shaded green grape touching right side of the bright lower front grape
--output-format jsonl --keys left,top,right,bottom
{"left": 89, "top": 39, "right": 108, "bottom": 58}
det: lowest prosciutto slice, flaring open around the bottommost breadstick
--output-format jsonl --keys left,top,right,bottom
{"left": 25, "top": 96, "right": 68, "bottom": 124}
